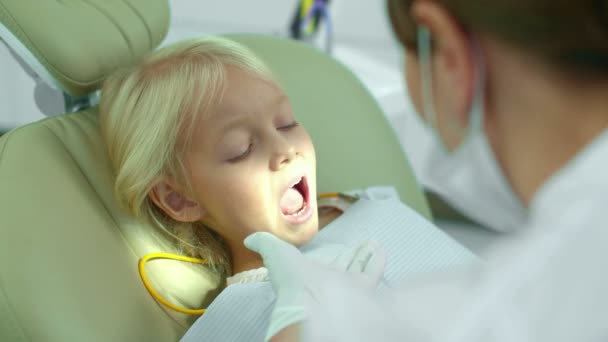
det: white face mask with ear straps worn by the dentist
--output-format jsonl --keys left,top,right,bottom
{"left": 418, "top": 27, "right": 528, "bottom": 232}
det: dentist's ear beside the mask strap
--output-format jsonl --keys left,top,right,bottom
{"left": 411, "top": 0, "right": 475, "bottom": 146}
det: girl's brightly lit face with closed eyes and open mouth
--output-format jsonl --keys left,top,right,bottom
{"left": 186, "top": 67, "right": 318, "bottom": 245}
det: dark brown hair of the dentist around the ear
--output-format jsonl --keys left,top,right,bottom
{"left": 387, "top": 0, "right": 608, "bottom": 74}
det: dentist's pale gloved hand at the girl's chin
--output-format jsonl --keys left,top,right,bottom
{"left": 245, "top": 232, "right": 386, "bottom": 340}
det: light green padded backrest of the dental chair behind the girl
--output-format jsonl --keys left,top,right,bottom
{"left": 0, "top": 0, "right": 429, "bottom": 342}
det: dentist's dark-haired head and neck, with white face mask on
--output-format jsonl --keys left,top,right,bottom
{"left": 388, "top": 0, "right": 608, "bottom": 230}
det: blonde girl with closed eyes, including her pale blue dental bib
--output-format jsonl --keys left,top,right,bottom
{"left": 100, "top": 38, "right": 471, "bottom": 341}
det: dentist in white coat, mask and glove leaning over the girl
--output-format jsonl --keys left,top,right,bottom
{"left": 245, "top": 0, "right": 608, "bottom": 342}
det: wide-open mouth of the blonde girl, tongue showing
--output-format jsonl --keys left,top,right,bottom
{"left": 279, "top": 177, "right": 312, "bottom": 224}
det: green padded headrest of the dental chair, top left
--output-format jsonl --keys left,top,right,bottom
{"left": 0, "top": 0, "right": 170, "bottom": 97}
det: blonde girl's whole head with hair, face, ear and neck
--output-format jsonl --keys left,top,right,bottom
{"left": 100, "top": 38, "right": 346, "bottom": 304}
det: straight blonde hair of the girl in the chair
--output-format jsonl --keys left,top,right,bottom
{"left": 100, "top": 37, "right": 273, "bottom": 275}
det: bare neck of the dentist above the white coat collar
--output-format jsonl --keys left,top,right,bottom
{"left": 485, "top": 41, "right": 608, "bottom": 206}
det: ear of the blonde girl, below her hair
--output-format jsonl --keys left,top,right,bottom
{"left": 148, "top": 180, "right": 205, "bottom": 222}
